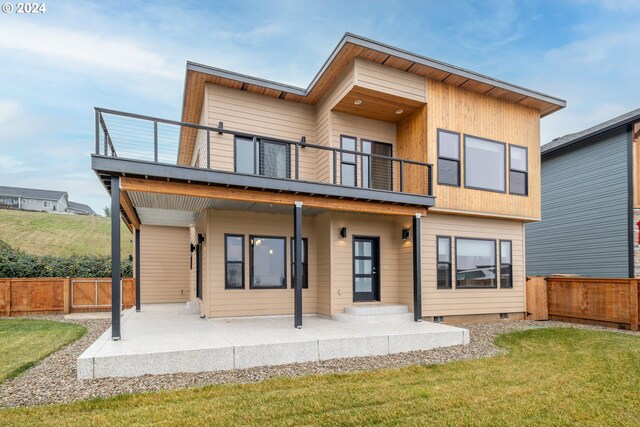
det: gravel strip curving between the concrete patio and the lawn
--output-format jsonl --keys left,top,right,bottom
{"left": 0, "top": 316, "right": 638, "bottom": 407}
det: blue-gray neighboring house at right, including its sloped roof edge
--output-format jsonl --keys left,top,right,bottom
{"left": 526, "top": 109, "right": 640, "bottom": 277}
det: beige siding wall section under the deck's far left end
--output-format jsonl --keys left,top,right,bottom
{"left": 140, "top": 225, "right": 190, "bottom": 304}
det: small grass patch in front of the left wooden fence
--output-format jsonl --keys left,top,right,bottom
{"left": 0, "top": 319, "right": 87, "bottom": 384}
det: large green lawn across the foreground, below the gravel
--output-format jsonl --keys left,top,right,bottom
{"left": 0, "top": 329, "right": 640, "bottom": 426}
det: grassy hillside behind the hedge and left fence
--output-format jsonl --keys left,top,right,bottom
{"left": 0, "top": 209, "right": 133, "bottom": 258}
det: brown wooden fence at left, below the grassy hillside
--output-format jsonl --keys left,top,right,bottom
{"left": 0, "top": 278, "right": 136, "bottom": 316}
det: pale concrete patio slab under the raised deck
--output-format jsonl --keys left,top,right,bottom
{"left": 77, "top": 304, "right": 469, "bottom": 379}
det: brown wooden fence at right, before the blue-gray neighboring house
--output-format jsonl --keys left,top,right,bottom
{"left": 527, "top": 277, "right": 640, "bottom": 331}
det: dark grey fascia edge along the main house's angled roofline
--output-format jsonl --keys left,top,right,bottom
{"left": 183, "top": 33, "right": 567, "bottom": 113}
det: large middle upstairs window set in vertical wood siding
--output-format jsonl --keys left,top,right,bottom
{"left": 464, "top": 136, "right": 506, "bottom": 193}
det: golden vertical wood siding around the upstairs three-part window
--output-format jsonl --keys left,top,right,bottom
{"left": 427, "top": 80, "right": 540, "bottom": 219}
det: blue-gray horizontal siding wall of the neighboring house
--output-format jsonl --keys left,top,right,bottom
{"left": 525, "top": 128, "right": 629, "bottom": 277}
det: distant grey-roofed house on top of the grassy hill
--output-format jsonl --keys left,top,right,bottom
{"left": 0, "top": 186, "right": 96, "bottom": 215}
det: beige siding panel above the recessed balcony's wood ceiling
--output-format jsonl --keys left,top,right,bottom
{"left": 355, "top": 58, "right": 427, "bottom": 102}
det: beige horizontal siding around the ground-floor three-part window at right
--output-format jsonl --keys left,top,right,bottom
{"left": 422, "top": 214, "right": 525, "bottom": 316}
